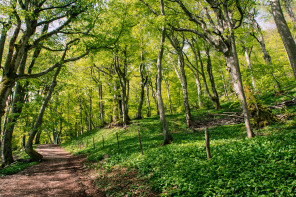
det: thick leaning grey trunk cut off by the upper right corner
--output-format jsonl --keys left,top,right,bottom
{"left": 270, "top": 0, "right": 296, "bottom": 79}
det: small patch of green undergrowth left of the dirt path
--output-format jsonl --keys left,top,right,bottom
{"left": 0, "top": 151, "right": 38, "bottom": 176}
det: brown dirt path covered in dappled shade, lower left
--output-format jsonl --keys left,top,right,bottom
{"left": 0, "top": 145, "right": 103, "bottom": 197}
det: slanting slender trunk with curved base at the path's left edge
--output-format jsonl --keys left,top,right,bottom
{"left": 26, "top": 66, "right": 61, "bottom": 161}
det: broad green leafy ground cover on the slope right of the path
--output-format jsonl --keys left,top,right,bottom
{"left": 63, "top": 89, "right": 296, "bottom": 196}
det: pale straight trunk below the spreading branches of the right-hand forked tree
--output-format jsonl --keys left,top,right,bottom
{"left": 224, "top": 34, "right": 254, "bottom": 138}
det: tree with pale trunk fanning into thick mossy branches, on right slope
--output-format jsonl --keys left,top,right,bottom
{"left": 174, "top": 0, "right": 254, "bottom": 138}
